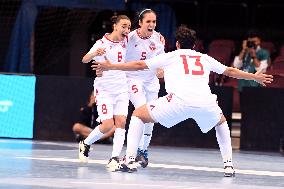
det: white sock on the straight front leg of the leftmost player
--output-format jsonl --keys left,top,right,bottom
{"left": 111, "top": 128, "right": 125, "bottom": 157}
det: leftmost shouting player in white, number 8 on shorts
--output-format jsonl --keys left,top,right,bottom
{"left": 79, "top": 15, "right": 131, "bottom": 171}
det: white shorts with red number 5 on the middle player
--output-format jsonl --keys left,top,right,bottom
{"left": 128, "top": 79, "right": 160, "bottom": 108}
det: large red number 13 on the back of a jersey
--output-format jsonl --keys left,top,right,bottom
{"left": 180, "top": 55, "right": 204, "bottom": 75}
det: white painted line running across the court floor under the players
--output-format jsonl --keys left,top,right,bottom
{"left": 16, "top": 156, "right": 284, "bottom": 177}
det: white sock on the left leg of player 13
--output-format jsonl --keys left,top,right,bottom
{"left": 126, "top": 116, "right": 144, "bottom": 163}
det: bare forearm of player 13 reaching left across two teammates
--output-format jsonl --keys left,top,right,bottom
{"left": 91, "top": 57, "right": 148, "bottom": 71}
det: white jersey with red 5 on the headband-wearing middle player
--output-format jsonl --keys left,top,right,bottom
{"left": 125, "top": 29, "right": 165, "bottom": 81}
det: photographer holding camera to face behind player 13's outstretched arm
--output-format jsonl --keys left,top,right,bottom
{"left": 233, "top": 30, "right": 270, "bottom": 92}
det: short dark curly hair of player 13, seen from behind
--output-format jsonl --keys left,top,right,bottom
{"left": 176, "top": 25, "right": 197, "bottom": 49}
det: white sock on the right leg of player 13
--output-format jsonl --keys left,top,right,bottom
{"left": 215, "top": 121, "right": 232, "bottom": 163}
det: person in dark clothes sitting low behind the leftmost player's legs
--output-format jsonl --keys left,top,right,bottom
{"left": 72, "top": 92, "right": 115, "bottom": 143}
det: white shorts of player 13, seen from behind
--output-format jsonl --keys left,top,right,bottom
{"left": 147, "top": 94, "right": 222, "bottom": 133}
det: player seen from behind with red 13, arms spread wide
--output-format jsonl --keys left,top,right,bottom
{"left": 92, "top": 26, "right": 273, "bottom": 177}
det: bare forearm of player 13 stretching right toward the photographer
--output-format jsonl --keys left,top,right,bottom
{"left": 223, "top": 67, "right": 273, "bottom": 86}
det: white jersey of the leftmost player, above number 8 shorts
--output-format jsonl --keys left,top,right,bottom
{"left": 88, "top": 34, "right": 128, "bottom": 94}
